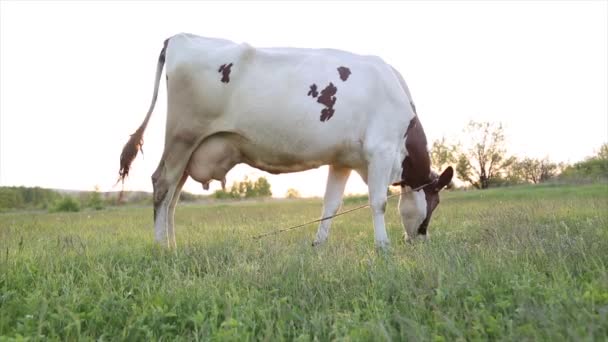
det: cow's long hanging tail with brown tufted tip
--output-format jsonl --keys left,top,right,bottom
{"left": 118, "top": 39, "right": 169, "bottom": 183}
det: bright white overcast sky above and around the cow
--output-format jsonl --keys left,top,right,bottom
{"left": 0, "top": 1, "right": 608, "bottom": 196}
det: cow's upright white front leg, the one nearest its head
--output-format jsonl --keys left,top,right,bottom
{"left": 367, "top": 153, "right": 392, "bottom": 249}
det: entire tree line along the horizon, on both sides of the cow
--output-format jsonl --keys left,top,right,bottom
{"left": 0, "top": 125, "right": 608, "bottom": 211}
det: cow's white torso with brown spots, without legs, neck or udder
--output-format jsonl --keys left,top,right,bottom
{"left": 167, "top": 34, "right": 412, "bottom": 169}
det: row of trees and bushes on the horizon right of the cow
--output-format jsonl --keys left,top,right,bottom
{"left": 430, "top": 121, "right": 608, "bottom": 189}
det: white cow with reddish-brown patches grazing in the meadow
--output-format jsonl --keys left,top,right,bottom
{"left": 119, "top": 34, "right": 453, "bottom": 247}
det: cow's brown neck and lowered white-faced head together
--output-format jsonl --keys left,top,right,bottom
{"left": 398, "top": 116, "right": 454, "bottom": 240}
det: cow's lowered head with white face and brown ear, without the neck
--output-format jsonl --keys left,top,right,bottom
{"left": 399, "top": 166, "right": 454, "bottom": 241}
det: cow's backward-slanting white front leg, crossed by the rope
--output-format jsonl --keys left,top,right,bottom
{"left": 312, "top": 165, "right": 351, "bottom": 246}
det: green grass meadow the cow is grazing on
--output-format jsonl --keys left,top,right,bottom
{"left": 0, "top": 184, "right": 608, "bottom": 341}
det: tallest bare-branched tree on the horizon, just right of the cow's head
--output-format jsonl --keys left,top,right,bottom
{"left": 456, "top": 121, "right": 516, "bottom": 189}
